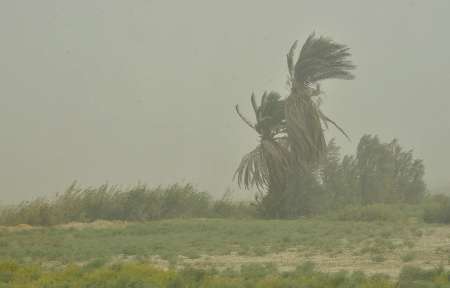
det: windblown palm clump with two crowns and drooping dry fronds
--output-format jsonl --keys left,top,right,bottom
{"left": 235, "top": 33, "right": 354, "bottom": 216}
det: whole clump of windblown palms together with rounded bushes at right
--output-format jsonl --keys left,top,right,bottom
{"left": 235, "top": 34, "right": 426, "bottom": 218}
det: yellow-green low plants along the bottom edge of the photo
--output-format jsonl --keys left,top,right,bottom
{"left": 0, "top": 262, "right": 450, "bottom": 288}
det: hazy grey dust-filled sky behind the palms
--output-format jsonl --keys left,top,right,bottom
{"left": 0, "top": 0, "right": 450, "bottom": 203}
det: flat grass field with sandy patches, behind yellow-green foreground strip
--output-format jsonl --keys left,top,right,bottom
{"left": 0, "top": 219, "right": 450, "bottom": 277}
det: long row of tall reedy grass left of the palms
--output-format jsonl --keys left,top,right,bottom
{"left": 0, "top": 183, "right": 253, "bottom": 226}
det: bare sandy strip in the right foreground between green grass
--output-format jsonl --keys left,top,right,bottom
{"left": 153, "top": 226, "right": 450, "bottom": 277}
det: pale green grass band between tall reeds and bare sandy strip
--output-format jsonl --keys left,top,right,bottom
{"left": 0, "top": 219, "right": 430, "bottom": 263}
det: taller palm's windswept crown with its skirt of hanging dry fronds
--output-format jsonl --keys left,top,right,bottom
{"left": 285, "top": 33, "right": 355, "bottom": 166}
